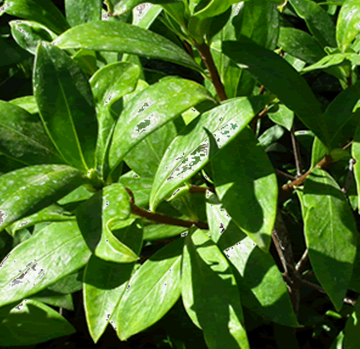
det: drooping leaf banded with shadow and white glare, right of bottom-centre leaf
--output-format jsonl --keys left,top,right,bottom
{"left": 206, "top": 194, "right": 298, "bottom": 327}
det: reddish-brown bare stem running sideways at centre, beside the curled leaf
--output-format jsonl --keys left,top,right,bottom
{"left": 125, "top": 188, "right": 209, "bottom": 230}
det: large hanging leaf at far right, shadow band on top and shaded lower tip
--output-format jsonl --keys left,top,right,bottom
{"left": 304, "top": 168, "right": 358, "bottom": 311}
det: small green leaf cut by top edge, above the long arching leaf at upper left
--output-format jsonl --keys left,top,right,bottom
{"left": 65, "top": 0, "right": 103, "bottom": 27}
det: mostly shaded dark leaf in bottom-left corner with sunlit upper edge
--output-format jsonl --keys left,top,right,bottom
{"left": 0, "top": 299, "right": 76, "bottom": 346}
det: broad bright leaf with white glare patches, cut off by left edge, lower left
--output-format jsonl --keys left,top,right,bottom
{"left": 0, "top": 221, "right": 91, "bottom": 306}
